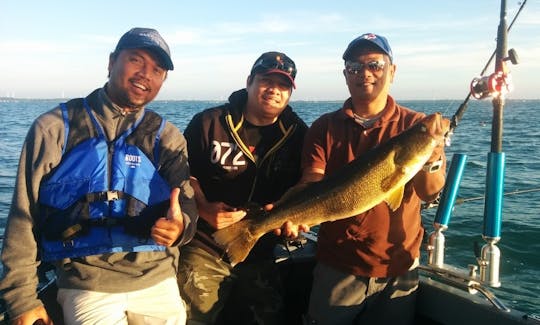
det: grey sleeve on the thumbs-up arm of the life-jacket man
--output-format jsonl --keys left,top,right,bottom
{"left": 160, "top": 122, "right": 199, "bottom": 246}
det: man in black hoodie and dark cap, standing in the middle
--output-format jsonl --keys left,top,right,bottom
{"left": 179, "top": 52, "right": 307, "bottom": 324}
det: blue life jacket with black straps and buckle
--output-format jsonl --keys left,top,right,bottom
{"left": 39, "top": 99, "right": 170, "bottom": 261}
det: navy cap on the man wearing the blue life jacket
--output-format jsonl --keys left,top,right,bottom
{"left": 114, "top": 27, "right": 174, "bottom": 70}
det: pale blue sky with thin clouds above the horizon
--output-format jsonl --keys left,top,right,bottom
{"left": 0, "top": 0, "right": 540, "bottom": 100}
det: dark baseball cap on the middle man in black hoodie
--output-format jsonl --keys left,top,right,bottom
{"left": 250, "top": 52, "right": 296, "bottom": 88}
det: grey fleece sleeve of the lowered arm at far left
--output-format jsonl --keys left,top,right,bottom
{"left": 0, "top": 109, "right": 64, "bottom": 318}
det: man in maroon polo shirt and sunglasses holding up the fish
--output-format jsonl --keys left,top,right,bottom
{"left": 301, "top": 34, "right": 445, "bottom": 325}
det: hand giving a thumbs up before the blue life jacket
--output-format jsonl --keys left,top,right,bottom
{"left": 150, "top": 187, "right": 184, "bottom": 247}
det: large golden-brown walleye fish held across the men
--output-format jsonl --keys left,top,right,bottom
{"left": 213, "top": 113, "right": 450, "bottom": 265}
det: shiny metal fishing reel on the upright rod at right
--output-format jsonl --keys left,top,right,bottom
{"left": 471, "top": 49, "right": 518, "bottom": 99}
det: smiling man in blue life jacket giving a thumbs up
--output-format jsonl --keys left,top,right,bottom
{"left": 0, "top": 28, "right": 198, "bottom": 324}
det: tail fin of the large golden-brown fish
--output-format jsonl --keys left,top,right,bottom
{"left": 212, "top": 219, "right": 260, "bottom": 266}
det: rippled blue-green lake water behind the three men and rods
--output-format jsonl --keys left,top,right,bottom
{"left": 0, "top": 100, "right": 540, "bottom": 314}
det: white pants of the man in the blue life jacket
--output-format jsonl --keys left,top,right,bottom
{"left": 58, "top": 278, "right": 187, "bottom": 325}
